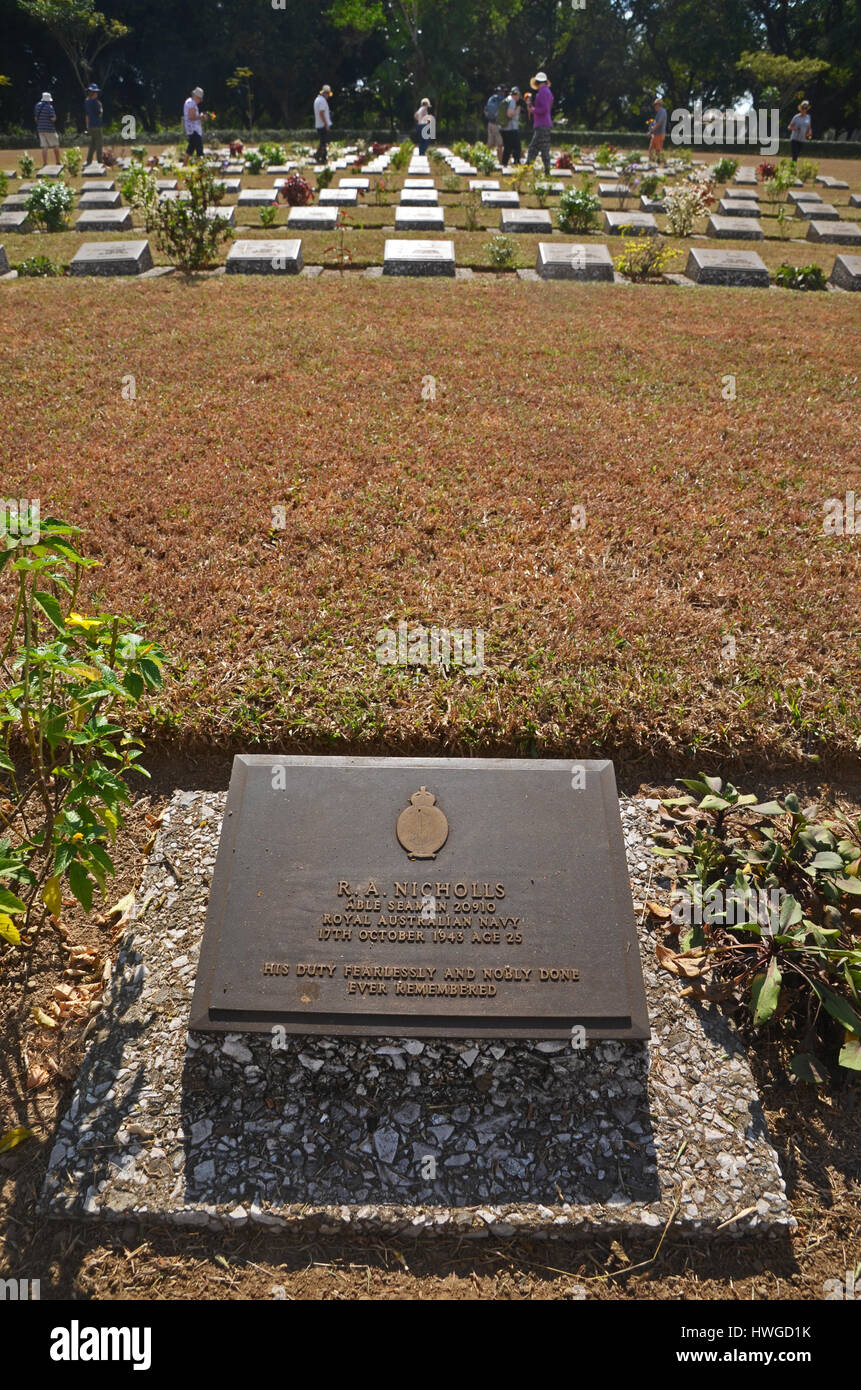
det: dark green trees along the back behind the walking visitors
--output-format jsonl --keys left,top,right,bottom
{"left": 0, "top": 0, "right": 861, "bottom": 133}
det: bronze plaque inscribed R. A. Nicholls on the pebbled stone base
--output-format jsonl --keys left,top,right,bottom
{"left": 191, "top": 756, "right": 650, "bottom": 1038}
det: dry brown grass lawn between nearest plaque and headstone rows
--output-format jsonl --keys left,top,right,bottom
{"left": 0, "top": 275, "right": 861, "bottom": 771}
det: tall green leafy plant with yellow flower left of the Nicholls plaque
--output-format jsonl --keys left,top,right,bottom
{"left": 0, "top": 517, "right": 164, "bottom": 947}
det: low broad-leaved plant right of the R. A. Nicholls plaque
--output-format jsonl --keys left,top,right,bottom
{"left": 657, "top": 776, "right": 861, "bottom": 1081}
